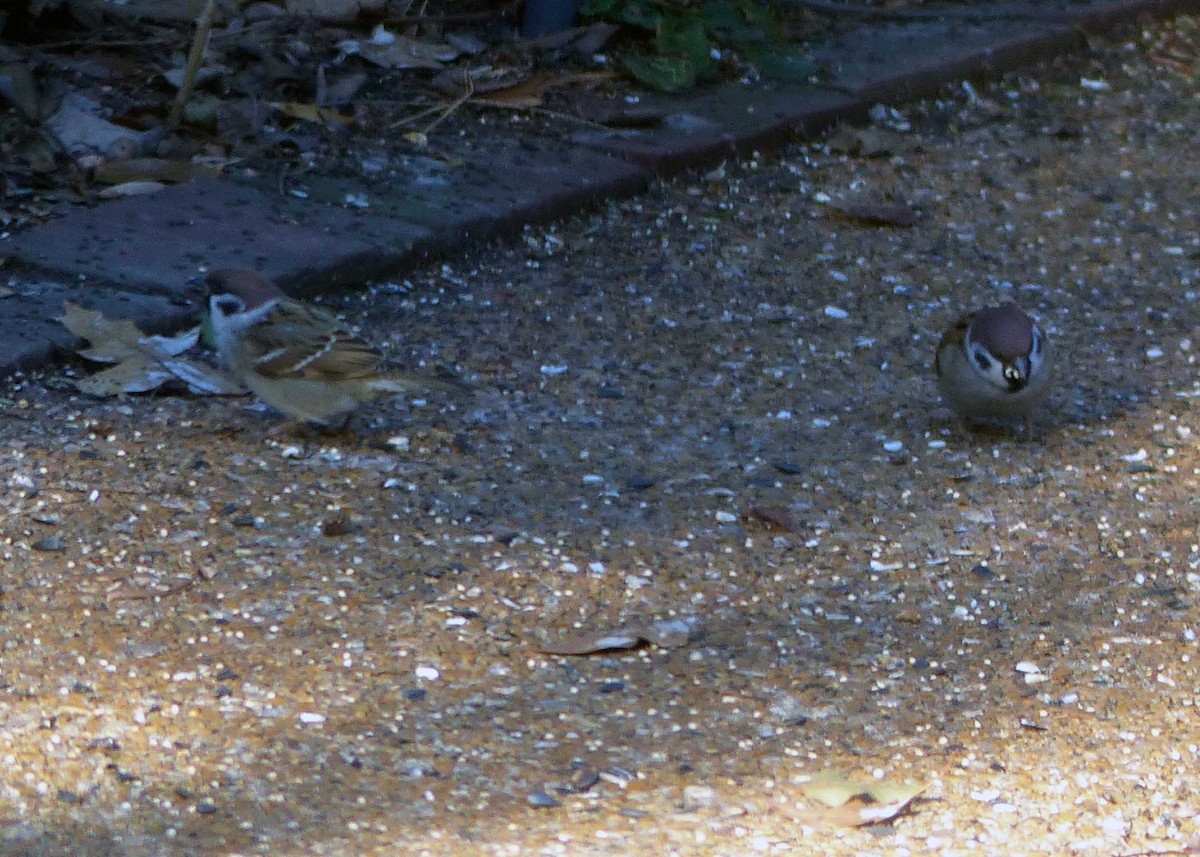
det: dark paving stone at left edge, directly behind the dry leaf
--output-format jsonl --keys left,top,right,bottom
{"left": 0, "top": 278, "right": 197, "bottom": 376}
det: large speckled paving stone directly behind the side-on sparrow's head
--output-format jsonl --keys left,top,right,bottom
{"left": 0, "top": 178, "right": 430, "bottom": 296}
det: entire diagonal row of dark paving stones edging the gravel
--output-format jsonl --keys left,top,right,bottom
{"left": 0, "top": 0, "right": 1200, "bottom": 381}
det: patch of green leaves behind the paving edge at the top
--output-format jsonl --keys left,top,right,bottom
{"left": 581, "top": 0, "right": 814, "bottom": 92}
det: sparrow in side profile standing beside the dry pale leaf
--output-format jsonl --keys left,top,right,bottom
{"left": 208, "top": 268, "right": 466, "bottom": 427}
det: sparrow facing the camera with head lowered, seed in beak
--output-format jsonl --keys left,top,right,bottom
{"left": 934, "top": 304, "right": 1054, "bottom": 439}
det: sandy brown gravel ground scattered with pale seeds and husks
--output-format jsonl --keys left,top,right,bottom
{"left": 7, "top": 13, "right": 1200, "bottom": 855}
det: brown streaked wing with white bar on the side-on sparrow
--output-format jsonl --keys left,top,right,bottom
{"left": 247, "top": 301, "right": 380, "bottom": 380}
